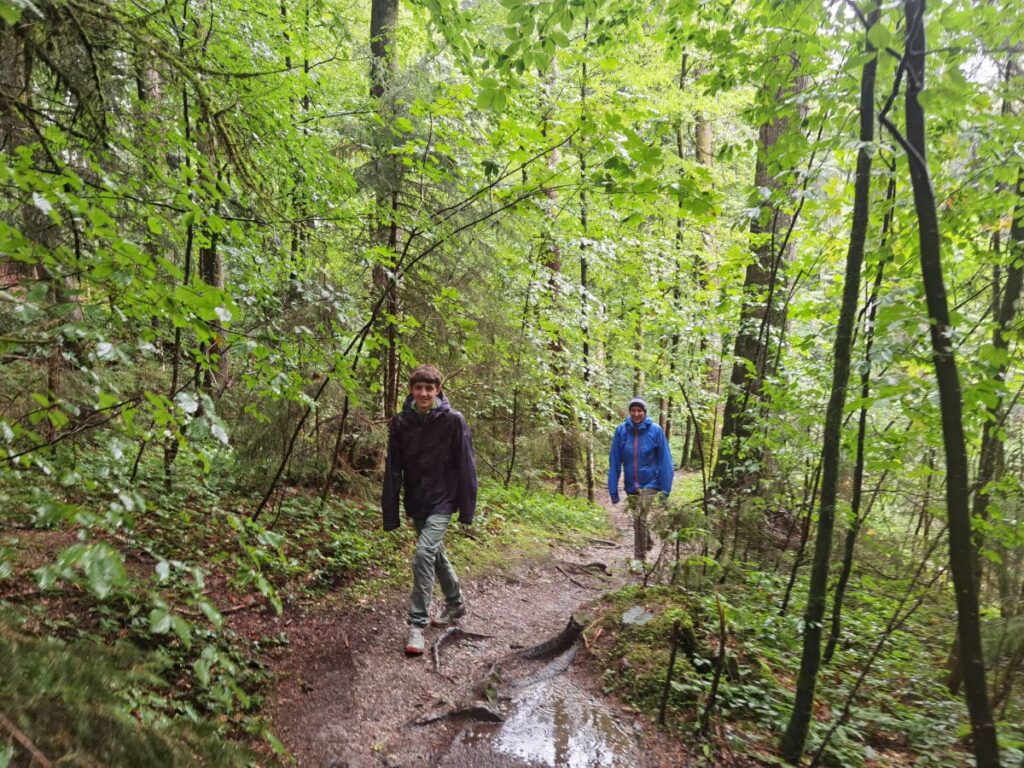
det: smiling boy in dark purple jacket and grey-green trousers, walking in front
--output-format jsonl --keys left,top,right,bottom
{"left": 381, "top": 366, "right": 476, "bottom": 655}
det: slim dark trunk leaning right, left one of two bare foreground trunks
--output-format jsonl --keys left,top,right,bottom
{"left": 781, "top": 15, "right": 879, "bottom": 763}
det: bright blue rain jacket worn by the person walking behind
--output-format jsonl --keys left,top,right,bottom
{"left": 608, "top": 417, "right": 675, "bottom": 504}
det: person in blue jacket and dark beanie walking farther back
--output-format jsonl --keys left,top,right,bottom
{"left": 608, "top": 397, "right": 674, "bottom": 570}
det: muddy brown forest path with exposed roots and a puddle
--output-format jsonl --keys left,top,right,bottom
{"left": 269, "top": 493, "right": 681, "bottom": 768}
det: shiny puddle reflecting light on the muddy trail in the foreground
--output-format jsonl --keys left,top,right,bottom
{"left": 442, "top": 678, "right": 638, "bottom": 768}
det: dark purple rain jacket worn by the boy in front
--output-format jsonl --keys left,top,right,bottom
{"left": 381, "top": 393, "right": 476, "bottom": 530}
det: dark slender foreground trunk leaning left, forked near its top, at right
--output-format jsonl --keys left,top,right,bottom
{"left": 883, "top": 0, "right": 999, "bottom": 768}
